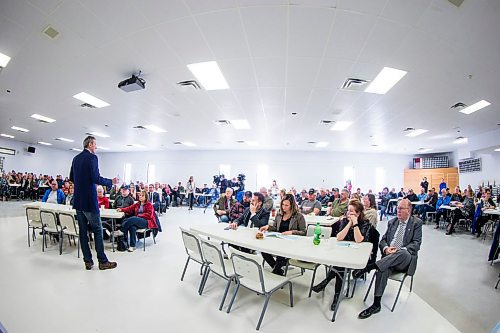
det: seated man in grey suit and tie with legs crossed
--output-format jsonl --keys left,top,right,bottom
{"left": 353, "top": 199, "right": 422, "bottom": 319}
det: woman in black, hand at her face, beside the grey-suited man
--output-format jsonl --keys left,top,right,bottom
{"left": 313, "top": 200, "right": 370, "bottom": 311}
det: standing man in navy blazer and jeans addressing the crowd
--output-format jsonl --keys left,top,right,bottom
{"left": 69, "top": 136, "right": 119, "bottom": 270}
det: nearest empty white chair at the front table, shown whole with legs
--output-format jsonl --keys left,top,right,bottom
{"left": 227, "top": 249, "right": 293, "bottom": 330}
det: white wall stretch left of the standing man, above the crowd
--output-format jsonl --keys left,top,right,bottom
{"left": 0, "top": 139, "right": 77, "bottom": 176}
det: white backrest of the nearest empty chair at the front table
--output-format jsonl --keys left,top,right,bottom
{"left": 231, "top": 248, "right": 266, "bottom": 294}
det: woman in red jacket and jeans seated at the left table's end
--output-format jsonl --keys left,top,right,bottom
{"left": 117, "top": 190, "right": 158, "bottom": 252}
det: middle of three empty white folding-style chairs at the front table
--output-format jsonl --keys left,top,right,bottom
{"left": 200, "top": 239, "right": 236, "bottom": 311}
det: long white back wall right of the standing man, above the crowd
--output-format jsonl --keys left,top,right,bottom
{"left": 100, "top": 151, "right": 411, "bottom": 191}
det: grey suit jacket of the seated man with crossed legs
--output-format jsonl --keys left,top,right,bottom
{"left": 379, "top": 216, "right": 422, "bottom": 275}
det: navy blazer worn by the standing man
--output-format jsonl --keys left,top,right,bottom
{"left": 69, "top": 149, "right": 112, "bottom": 213}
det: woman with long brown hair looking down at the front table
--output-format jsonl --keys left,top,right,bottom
{"left": 260, "top": 194, "right": 306, "bottom": 275}
